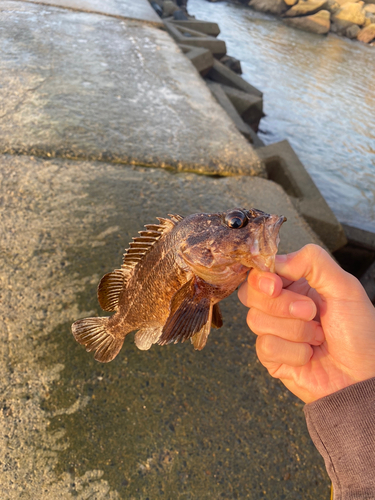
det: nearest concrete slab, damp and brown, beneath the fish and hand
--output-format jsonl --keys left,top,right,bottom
{"left": 0, "top": 155, "right": 329, "bottom": 500}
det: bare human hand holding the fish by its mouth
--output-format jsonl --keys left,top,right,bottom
{"left": 238, "top": 245, "right": 375, "bottom": 403}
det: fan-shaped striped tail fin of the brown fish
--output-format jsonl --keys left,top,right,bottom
{"left": 72, "top": 318, "right": 124, "bottom": 363}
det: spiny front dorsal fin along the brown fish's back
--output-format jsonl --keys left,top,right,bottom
{"left": 121, "top": 215, "right": 183, "bottom": 270}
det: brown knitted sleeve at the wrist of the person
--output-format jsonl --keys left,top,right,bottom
{"left": 304, "top": 377, "right": 375, "bottom": 500}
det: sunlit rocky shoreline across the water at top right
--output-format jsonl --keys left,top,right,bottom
{"left": 207, "top": 0, "right": 375, "bottom": 46}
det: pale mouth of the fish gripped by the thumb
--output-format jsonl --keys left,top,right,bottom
{"left": 242, "top": 215, "right": 287, "bottom": 272}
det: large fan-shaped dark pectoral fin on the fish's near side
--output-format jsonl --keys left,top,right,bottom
{"left": 158, "top": 278, "right": 212, "bottom": 345}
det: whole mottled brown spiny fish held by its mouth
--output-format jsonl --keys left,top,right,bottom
{"left": 72, "top": 208, "right": 286, "bottom": 363}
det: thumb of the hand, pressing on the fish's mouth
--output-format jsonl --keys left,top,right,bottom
{"left": 276, "top": 244, "right": 357, "bottom": 298}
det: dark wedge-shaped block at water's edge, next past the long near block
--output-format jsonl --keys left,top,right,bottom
{"left": 222, "top": 85, "right": 264, "bottom": 131}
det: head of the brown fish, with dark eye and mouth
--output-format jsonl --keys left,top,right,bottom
{"left": 179, "top": 208, "right": 286, "bottom": 284}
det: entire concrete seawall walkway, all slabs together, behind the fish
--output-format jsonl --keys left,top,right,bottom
{"left": 0, "top": 0, "right": 356, "bottom": 500}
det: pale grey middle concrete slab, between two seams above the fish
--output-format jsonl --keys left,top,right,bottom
{"left": 0, "top": 1, "right": 265, "bottom": 175}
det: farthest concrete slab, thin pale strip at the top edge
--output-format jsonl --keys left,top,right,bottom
{"left": 12, "top": 0, "right": 163, "bottom": 26}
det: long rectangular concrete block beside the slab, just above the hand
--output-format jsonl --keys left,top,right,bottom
{"left": 257, "top": 140, "right": 347, "bottom": 252}
